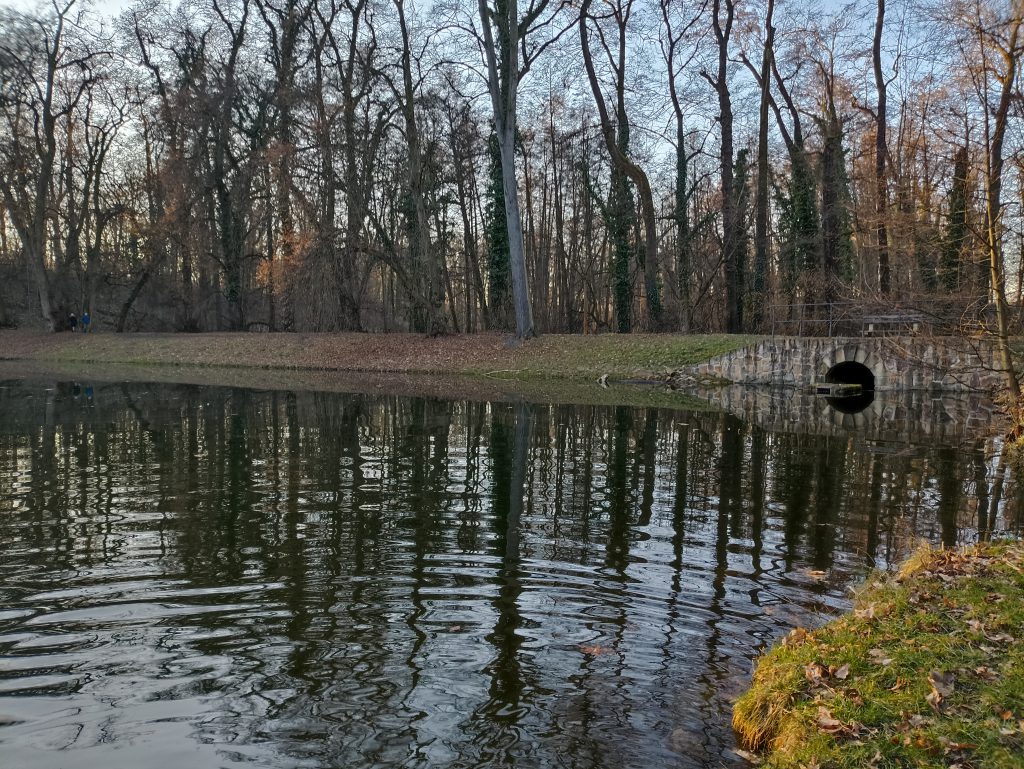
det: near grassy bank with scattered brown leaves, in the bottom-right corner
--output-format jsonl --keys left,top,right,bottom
{"left": 733, "top": 543, "right": 1024, "bottom": 769}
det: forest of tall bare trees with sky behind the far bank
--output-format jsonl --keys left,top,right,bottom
{"left": 0, "top": 0, "right": 1024, "bottom": 338}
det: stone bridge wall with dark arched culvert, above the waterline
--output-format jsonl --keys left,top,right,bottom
{"left": 689, "top": 336, "right": 998, "bottom": 391}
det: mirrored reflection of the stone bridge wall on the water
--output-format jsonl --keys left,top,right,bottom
{"left": 701, "top": 385, "right": 997, "bottom": 445}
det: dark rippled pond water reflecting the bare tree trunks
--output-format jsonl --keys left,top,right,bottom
{"left": 0, "top": 379, "right": 1021, "bottom": 769}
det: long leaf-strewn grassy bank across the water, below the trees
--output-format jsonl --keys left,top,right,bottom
{"left": 0, "top": 331, "right": 751, "bottom": 381}
